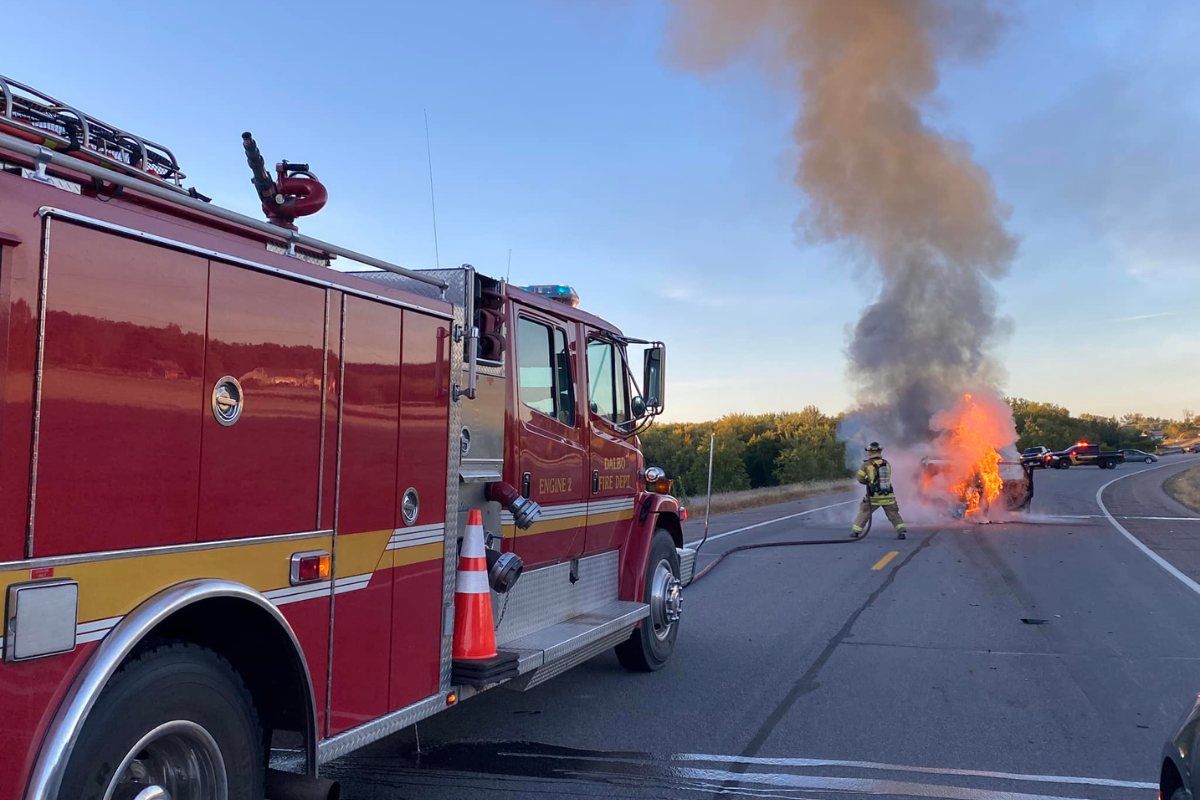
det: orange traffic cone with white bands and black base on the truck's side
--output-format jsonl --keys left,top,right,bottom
{"left": 451, "top": 509, "right": 517, "bottom": 686}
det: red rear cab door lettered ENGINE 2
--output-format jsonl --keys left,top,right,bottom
{"left": 504, "top": 306, "right": 589, "bottom": 569}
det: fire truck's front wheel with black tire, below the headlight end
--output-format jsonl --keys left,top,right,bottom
{"left": 617, "top": 528, "right": 683, "bottom": 672}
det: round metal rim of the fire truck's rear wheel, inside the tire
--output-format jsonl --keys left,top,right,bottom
{"left": 104, "top": 720, "right": 229, "bottom": 800}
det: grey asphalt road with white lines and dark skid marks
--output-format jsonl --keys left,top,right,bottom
{"left": 325, "top": 456, "right": 1200, "bottom": 800}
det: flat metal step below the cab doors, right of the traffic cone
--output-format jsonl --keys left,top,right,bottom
{"left": 500, "top": 600, "right": 650, "bottom": 692}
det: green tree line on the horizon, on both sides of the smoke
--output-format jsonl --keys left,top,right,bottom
{"left": 641, "top": 397, "right": 1200, "bottom": 497}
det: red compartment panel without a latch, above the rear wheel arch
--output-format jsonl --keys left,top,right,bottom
{"left": 34, "top": 219, "right": 209, "bottom": 557}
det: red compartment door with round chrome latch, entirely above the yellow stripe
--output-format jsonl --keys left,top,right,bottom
{"left": 199, "top": 261, "right": 325, "bottom": 541}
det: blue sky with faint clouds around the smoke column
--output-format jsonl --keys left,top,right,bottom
{"left": 0, "top": 0, "right": 1200, "bottom": 420}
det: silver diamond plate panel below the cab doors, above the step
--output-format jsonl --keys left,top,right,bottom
{"left": 492, "top": 551, "right": 618, "bottom": 645}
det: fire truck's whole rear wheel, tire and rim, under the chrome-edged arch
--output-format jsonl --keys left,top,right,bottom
{"left": 59, "top": 642, "right": 265, "bottom": 800}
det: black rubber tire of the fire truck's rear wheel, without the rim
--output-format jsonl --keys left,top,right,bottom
{"left": 59, "top": 642, "right": 266, "bottom": 800}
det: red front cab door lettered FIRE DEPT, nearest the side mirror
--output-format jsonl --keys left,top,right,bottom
{"left": 584, "top": 331, "right": 641, "bottom": 553}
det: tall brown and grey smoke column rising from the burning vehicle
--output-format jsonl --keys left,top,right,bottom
{"left": 668, "top": 0, "right": 1016, "bottom": 445}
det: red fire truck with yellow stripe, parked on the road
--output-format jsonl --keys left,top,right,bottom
{"left": 0, "top": 78, "right": 695, "bottom": 800}
